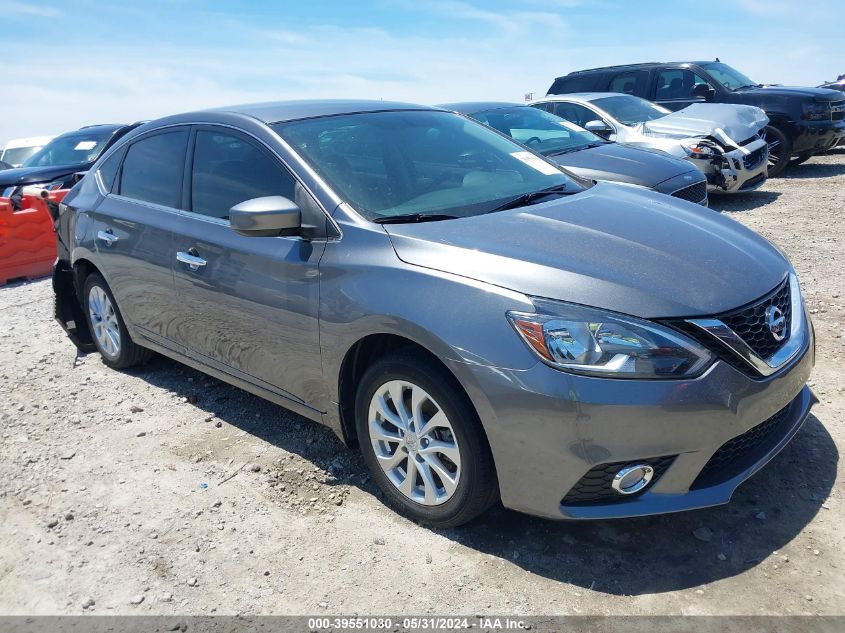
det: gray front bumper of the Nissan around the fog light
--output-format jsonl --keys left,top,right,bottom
{"left": 458, "top": 324, "right": 816, "bottom": 519}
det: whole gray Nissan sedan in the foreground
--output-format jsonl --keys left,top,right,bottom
{"left": 54, "top": 101, "right": 814, "bottom": 526}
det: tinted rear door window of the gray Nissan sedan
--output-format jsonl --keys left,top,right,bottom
{"left": 120, "top": 130, "right": 188, "bottom": 208}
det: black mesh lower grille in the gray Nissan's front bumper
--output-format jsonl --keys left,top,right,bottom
{"left": 690, "top": 403, "right": 791, "bottom": 490}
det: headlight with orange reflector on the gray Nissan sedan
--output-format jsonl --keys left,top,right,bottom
{"left": 507, "top": 299, "right": 713, "bottom": 378}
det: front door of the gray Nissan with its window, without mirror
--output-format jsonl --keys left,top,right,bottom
{"left": 168, "top": 126, "right": 325, "bottom": 404}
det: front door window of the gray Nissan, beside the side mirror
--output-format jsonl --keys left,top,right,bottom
{"left": 191, "top": 130, "right": 295, "bottom": 219}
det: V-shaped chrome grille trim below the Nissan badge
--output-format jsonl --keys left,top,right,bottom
{"left": 686, "top": 272, "right": 808, "bottom": 376}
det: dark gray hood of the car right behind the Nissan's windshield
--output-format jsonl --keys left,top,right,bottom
{"left": 548, "top": 143, "right": 696, "bottom": 188}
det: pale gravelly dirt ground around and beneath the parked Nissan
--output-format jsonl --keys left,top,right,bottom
{"left": 0, "top": 151, "right": 845, "bottom": 615}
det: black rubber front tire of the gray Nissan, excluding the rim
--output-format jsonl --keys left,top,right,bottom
{"left": 355, "top": 355, "right": 498, "bottom": 527}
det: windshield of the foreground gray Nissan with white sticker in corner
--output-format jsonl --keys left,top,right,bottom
{"left": 272, "top": 110, "right": 583, "bottom": 221}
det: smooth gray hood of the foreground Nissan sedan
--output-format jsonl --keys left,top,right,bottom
{"left": 384, "top": 183, "right": 789, "bottom": 318}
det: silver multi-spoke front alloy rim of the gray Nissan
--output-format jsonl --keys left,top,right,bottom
{"left": 368, "top": 380, "right": 461, "bottom": 506}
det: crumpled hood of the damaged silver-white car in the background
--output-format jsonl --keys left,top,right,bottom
{"left": 642, "top": 103, "right": 769, "bottom": 145}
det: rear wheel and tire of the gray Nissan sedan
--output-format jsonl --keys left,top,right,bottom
{"left": 82, "top": 273, "right": 153, "bottom": 369}
